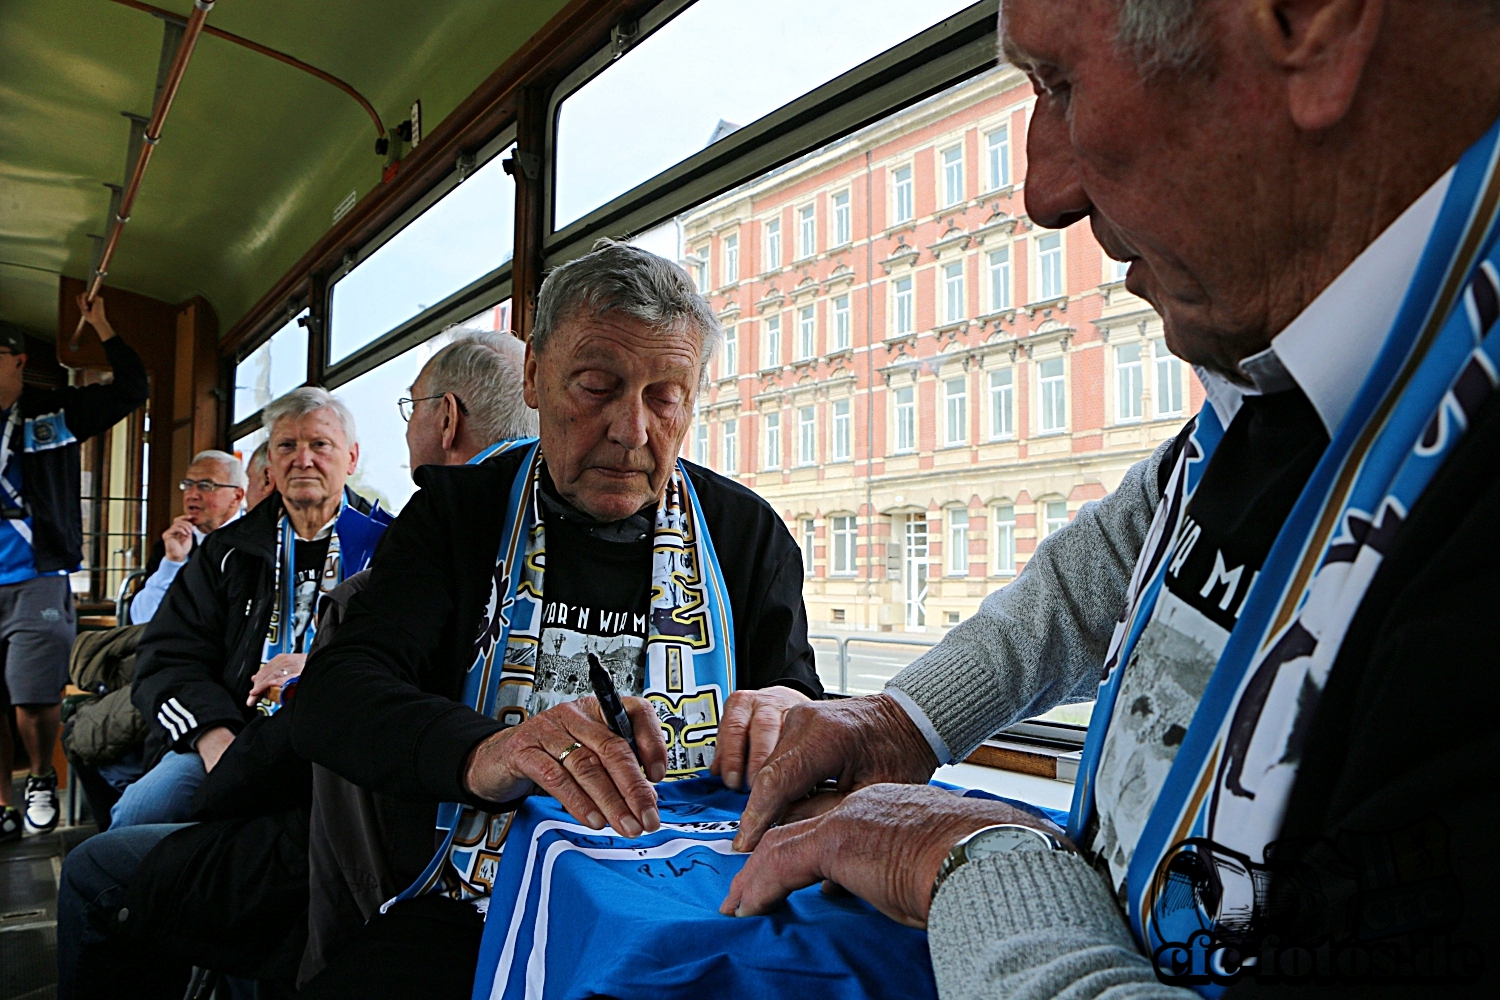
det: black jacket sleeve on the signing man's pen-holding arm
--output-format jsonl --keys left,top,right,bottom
{"left": 293, "top": 489, "right": 503, "bottom": 805}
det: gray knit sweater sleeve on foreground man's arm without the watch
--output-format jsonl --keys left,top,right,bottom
{"left": 887, "top": 441, "right": 1172, "bottom": 763}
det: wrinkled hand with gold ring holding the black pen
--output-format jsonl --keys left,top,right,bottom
{"left": 464, "top": 697, "right": 666, "bottom": 837}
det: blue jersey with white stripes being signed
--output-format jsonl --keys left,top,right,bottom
{"left": 474, "top": 778, "right": 938, "bottom": 1000}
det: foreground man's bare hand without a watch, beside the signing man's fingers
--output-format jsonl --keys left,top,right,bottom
{"left": 735, "top": 694, "right": 938, "bottom": 852}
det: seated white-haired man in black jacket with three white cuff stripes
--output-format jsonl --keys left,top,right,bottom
{"left": 111, "top": 387, "right": 371, "bottom": 832}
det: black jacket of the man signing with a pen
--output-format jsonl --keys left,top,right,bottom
{"left": 292, "top": 448, "right": 822, "bottom": 815}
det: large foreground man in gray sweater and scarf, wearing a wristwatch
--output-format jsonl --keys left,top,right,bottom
{"left": 723, "top": 0, "right": 1500, "bottom": 999}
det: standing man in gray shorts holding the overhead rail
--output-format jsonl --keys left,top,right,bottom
{"left": 0, "top": 297, "right": 150, "bottom": 841}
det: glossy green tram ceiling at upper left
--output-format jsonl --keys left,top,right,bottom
{"left": 0, "top": 0, "right": 566, "bottom": 337}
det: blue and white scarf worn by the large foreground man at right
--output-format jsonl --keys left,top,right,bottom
{"left": 1068, "top": 124, "right": 1500, "bottom": 997}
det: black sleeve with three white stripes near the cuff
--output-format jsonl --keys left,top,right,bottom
{"left": 131, "top": 547, "right": 245, "bottom": 751}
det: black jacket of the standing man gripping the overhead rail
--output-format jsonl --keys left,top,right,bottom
{"left": 11, "top": 337, "right": 152, "bottom": 573}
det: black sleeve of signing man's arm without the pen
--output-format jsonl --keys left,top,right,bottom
{"left": 740, "top": 542, "right": 824, "bottom": 699}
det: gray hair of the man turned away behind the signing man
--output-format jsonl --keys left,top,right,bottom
{"left": 417, "top": 330, "right": 537, "bottom": 447}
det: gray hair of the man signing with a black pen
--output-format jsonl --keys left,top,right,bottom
{"left": 531, "top": 240, "right": 725, "bottom": 376}
